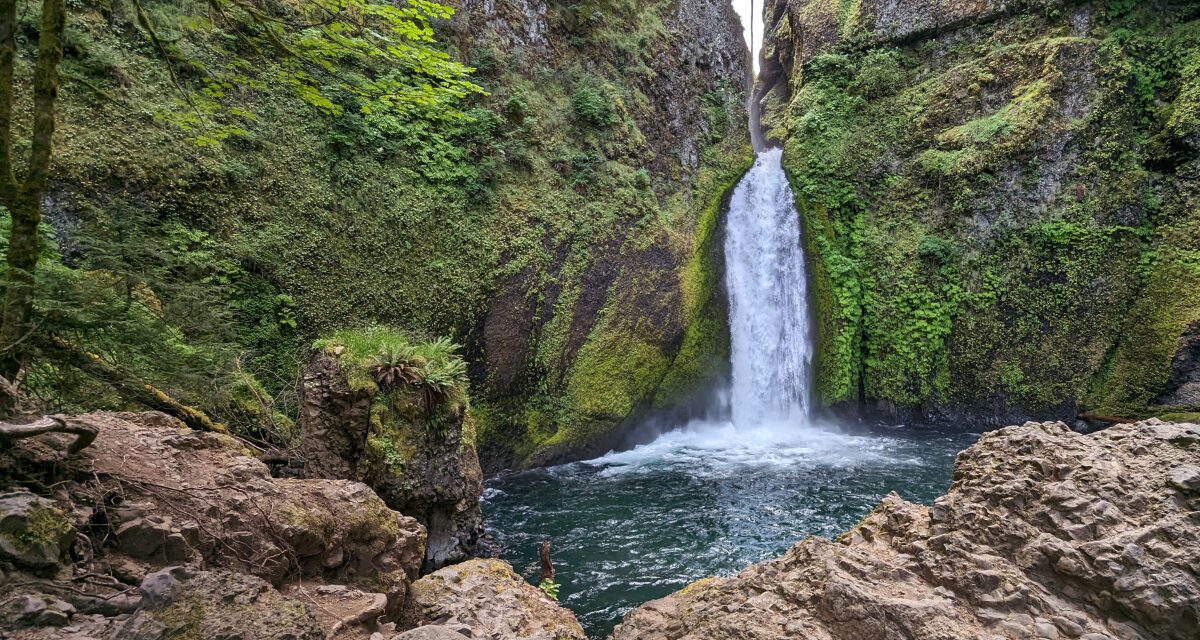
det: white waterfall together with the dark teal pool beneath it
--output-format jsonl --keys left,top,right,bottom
{"left": 484, "top": 149, "right": 972, "bottom": 639}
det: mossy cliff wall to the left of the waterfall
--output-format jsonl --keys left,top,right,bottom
{"left": 32, "top": 0, "right": 749, "bottom": 467}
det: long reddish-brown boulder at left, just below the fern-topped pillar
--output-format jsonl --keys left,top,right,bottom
{"left": 80, "top": 413, "right": 426, "bottom": 595}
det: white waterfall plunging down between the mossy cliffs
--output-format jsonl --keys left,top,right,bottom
{"left": 725, "top": 149, "right": 812, "bottom": 427}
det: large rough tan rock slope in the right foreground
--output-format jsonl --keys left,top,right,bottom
{"left": 612, "top": 421, "right": 1200, "bottom": 640}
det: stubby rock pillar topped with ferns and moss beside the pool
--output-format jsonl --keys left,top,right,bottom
{"left": 300, "top": 328, "right": 484, "bottom": 569}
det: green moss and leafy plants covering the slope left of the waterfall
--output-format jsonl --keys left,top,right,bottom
{"left": 6, "top": 0, "right": 749, "bottom": 465}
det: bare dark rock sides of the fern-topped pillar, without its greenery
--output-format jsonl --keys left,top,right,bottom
{"left": 300, "top": 351, "right": 484, "bottom": 570}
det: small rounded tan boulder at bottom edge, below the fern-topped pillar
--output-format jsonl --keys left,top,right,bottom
{"left": 401, "top": 560, "right": 587, "bottom": 640}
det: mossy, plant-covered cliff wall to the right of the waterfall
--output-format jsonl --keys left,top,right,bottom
{"left": 756, "top": 0, "right": 1200, "bottom": 426}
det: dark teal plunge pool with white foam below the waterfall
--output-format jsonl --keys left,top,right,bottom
{"left": 484, "top": 424, "right": 978, "bottom": 638}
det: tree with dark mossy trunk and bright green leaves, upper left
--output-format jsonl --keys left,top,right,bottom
{"left": 0, "top": 0, "right": 482, "bottom": 419}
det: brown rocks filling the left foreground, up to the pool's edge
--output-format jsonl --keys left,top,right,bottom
{"left": 0, "top": 413, "right": 584, "bottom": 640}
